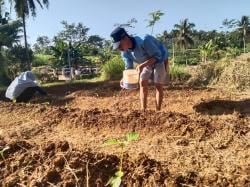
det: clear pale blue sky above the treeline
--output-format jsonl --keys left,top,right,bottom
{"left": 7, "top": 0, "right": 250, "bottom": 44}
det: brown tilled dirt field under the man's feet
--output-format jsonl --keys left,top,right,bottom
{"left": 0, "top": 82, "right": 250, "bottom": 187}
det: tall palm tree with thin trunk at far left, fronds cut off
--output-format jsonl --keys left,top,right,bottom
{"left": 10, "top": 0, "right": 49, "bottom": 69}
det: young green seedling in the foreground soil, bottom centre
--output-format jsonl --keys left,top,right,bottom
{"left": 103, "top": 132, "right": 139, "bottom": 187}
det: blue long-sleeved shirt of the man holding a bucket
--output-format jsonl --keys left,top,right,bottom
{"left": 121, "top": 35, "right": 168, "bottom": 69}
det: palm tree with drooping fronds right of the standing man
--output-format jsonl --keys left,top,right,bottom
{"left": 174, "top": 19, "right": 195, "bottom": 64}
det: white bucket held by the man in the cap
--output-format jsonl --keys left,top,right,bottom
{"left": 121, "top": 69, "right": 139, "bottom": 89}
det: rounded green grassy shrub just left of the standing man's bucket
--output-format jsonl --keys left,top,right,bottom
{"left": 101, "top": 56, "right": 124, "bottom": 80}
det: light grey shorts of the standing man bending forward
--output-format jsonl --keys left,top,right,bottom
{"left": 140, "top": 62, "right": 169, "bottom": 84}
